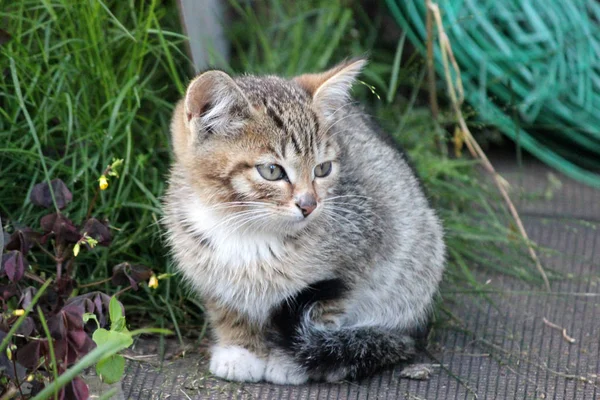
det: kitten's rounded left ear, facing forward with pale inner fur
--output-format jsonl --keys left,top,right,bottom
{"left": 184, "top": 71, "right": 252, "bottom": 135}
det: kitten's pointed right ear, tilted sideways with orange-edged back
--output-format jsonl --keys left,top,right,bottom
{"left": 294, "top": 58, "right": 367, "bottom": 117}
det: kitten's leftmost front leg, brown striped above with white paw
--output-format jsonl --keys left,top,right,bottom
{"left": 205, "top": 301, "right": 268, "bottom": 382}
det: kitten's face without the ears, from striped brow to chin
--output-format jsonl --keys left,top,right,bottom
{"left": 180, "top": 96, "right": 340, "bottom": 232}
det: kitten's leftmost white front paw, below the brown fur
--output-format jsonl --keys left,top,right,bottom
{"left": 210, "top": 346, "right": 267, "bottom": 382}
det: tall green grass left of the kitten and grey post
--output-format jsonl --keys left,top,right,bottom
{"left": 0, "top": 0, "right": 190, "bottom": 332}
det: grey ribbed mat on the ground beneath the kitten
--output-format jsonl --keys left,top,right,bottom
{"left": 116, "top": 155, "right": 600, "bottom": 400}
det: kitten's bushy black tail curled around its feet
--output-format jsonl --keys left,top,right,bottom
{"left": 270, "top": 279, "right": 416, "bottom": 380}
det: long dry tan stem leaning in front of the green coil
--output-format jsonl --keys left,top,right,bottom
{"left": 427, "top": 0, "right": 550, "bottom": 291}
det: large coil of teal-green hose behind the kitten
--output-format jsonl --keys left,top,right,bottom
{"left": 386, "top": 0, "right": 600, "bottom": 187}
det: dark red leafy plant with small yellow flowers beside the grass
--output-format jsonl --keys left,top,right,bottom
{"left": 0, "top": 179, "right": 153, "bottom": 400}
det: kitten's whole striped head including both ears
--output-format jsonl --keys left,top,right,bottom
{"left": 172, "top": 59, "right": 362, "bottom": 233}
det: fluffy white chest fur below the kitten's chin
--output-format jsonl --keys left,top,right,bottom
{"left": 179, "top": 200, "right": 312, "bottom": 322}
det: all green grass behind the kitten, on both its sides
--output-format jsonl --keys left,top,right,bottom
{"left": 0, "top": 0, "right": 539, "bottom": 335}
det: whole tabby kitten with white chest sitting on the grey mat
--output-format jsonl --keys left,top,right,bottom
{"left": 164, "top": 59, "right": 445, "bottom": 384}
